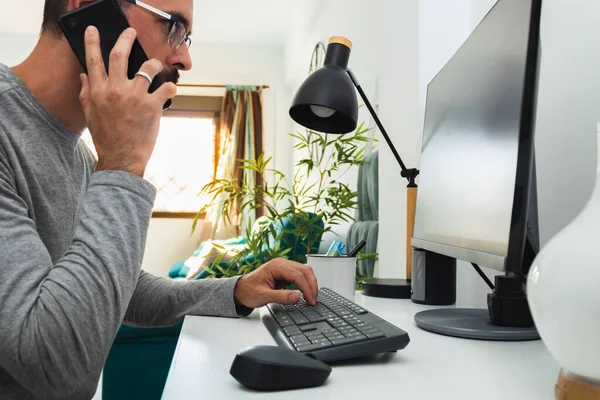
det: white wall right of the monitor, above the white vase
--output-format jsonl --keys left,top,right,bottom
{"left": 536, "top": 0, "right": 600, "bottom": 243}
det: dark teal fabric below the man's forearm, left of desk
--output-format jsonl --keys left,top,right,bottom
{"left": 102, "top": 321, "right": 183, "bottom": 400}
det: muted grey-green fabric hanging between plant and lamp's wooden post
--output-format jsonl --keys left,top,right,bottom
{"left": 346, "top": 151, "right": 379, "bottom": 276}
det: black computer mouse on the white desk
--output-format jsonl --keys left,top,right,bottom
{"left": 229, "top": 346, "right": 331, "bottom": 390}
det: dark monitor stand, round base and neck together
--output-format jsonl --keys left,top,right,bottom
{"left": 415, "top": 275, "right": 540, "bottom": 341}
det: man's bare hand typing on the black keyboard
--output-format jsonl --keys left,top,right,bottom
{"left": 234, "top": 258, "right": 318, "bottom": 308}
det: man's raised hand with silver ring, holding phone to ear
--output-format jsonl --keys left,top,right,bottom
{"left": 79, "top": 26, "right": 177, "bottom": 177}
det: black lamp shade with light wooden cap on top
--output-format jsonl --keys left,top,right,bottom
{"left": 290, "top": 37, "right": 358, "bottom": 134}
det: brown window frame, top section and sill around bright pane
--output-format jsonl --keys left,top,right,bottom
{"left": 151, "top": 95, "right": 223, "bottom": 219}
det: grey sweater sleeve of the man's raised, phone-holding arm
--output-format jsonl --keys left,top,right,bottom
{"left": 0, "top": 162, "right": 155, "bottom": 399}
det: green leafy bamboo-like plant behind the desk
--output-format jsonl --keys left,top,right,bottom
{"left": 192, "top": 123, "right": 374, "bottom": 277}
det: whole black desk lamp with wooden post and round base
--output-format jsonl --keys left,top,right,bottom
{"left": 290, "top": 36, "right": 419, "bottom": 298}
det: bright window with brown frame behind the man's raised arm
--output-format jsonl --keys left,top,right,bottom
{"left": 83, "top": 96, "right": 221, "bottom": 218}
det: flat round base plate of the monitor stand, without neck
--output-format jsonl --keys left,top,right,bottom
{"left": 415, "top": 308, "right": 540, "bottom": 341}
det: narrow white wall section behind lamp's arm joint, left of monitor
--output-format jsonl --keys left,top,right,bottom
{"left": 372, "top": 0, "right": 422, "bottom": 278}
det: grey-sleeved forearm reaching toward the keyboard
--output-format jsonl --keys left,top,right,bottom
{"left": 124, "top": 271, "right": 251, "bottom": 327}
